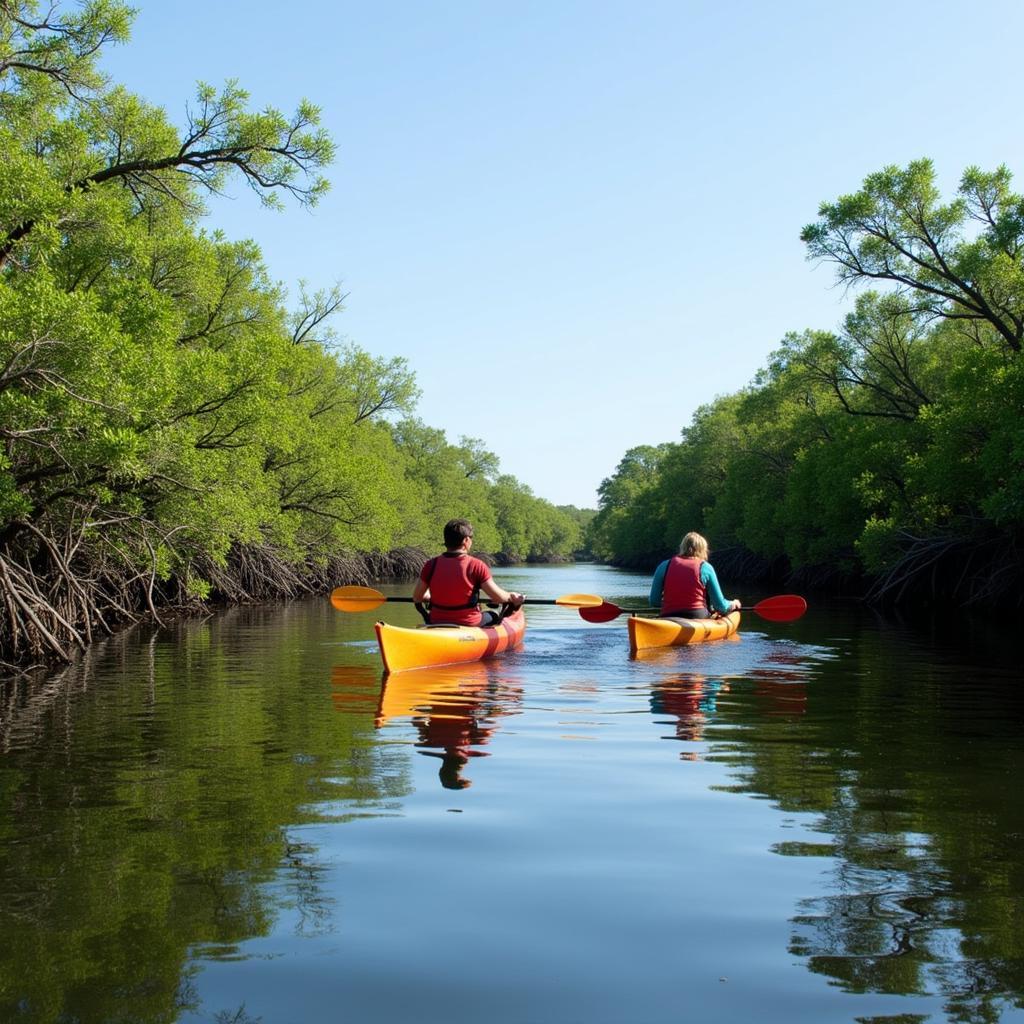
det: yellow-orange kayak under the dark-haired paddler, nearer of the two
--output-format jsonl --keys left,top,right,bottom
{"left": 375, "top": 608, "right": 526, "bottom": 673}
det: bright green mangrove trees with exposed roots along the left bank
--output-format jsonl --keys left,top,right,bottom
{"left": 0, "top": 0, "right": 582, "bottom": 668}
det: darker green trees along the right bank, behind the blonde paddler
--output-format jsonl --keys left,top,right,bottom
{"left": 589, "top": 160, "right": 1024, "bottom": 606}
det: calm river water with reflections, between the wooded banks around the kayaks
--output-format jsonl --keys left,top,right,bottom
{"left": 0, "top": 566, "right": 1024, "bottom": 1024}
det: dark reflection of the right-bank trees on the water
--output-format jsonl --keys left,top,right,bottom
{"left": 709, "top": 634, "right": 1024, "bottom": 1024}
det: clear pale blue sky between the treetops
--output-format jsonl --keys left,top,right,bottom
{"left": 105, "top": 0, "right": 1024, "bottom": 507}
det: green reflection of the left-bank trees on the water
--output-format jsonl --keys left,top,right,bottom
{"left": 0, "top": 608, "right": 399, "bottom": 1022}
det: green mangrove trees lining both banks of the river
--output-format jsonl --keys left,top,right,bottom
{"left": 0, "top": 6, "right": 1024, "bottom": 672}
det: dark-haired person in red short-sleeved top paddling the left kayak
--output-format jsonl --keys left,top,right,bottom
{"left": 413, "top": 519, "right": 525, "bottom": 626}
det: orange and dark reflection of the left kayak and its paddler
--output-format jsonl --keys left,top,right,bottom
{"left": 376, "top": 663, "right": 522, "bottom": 790}
